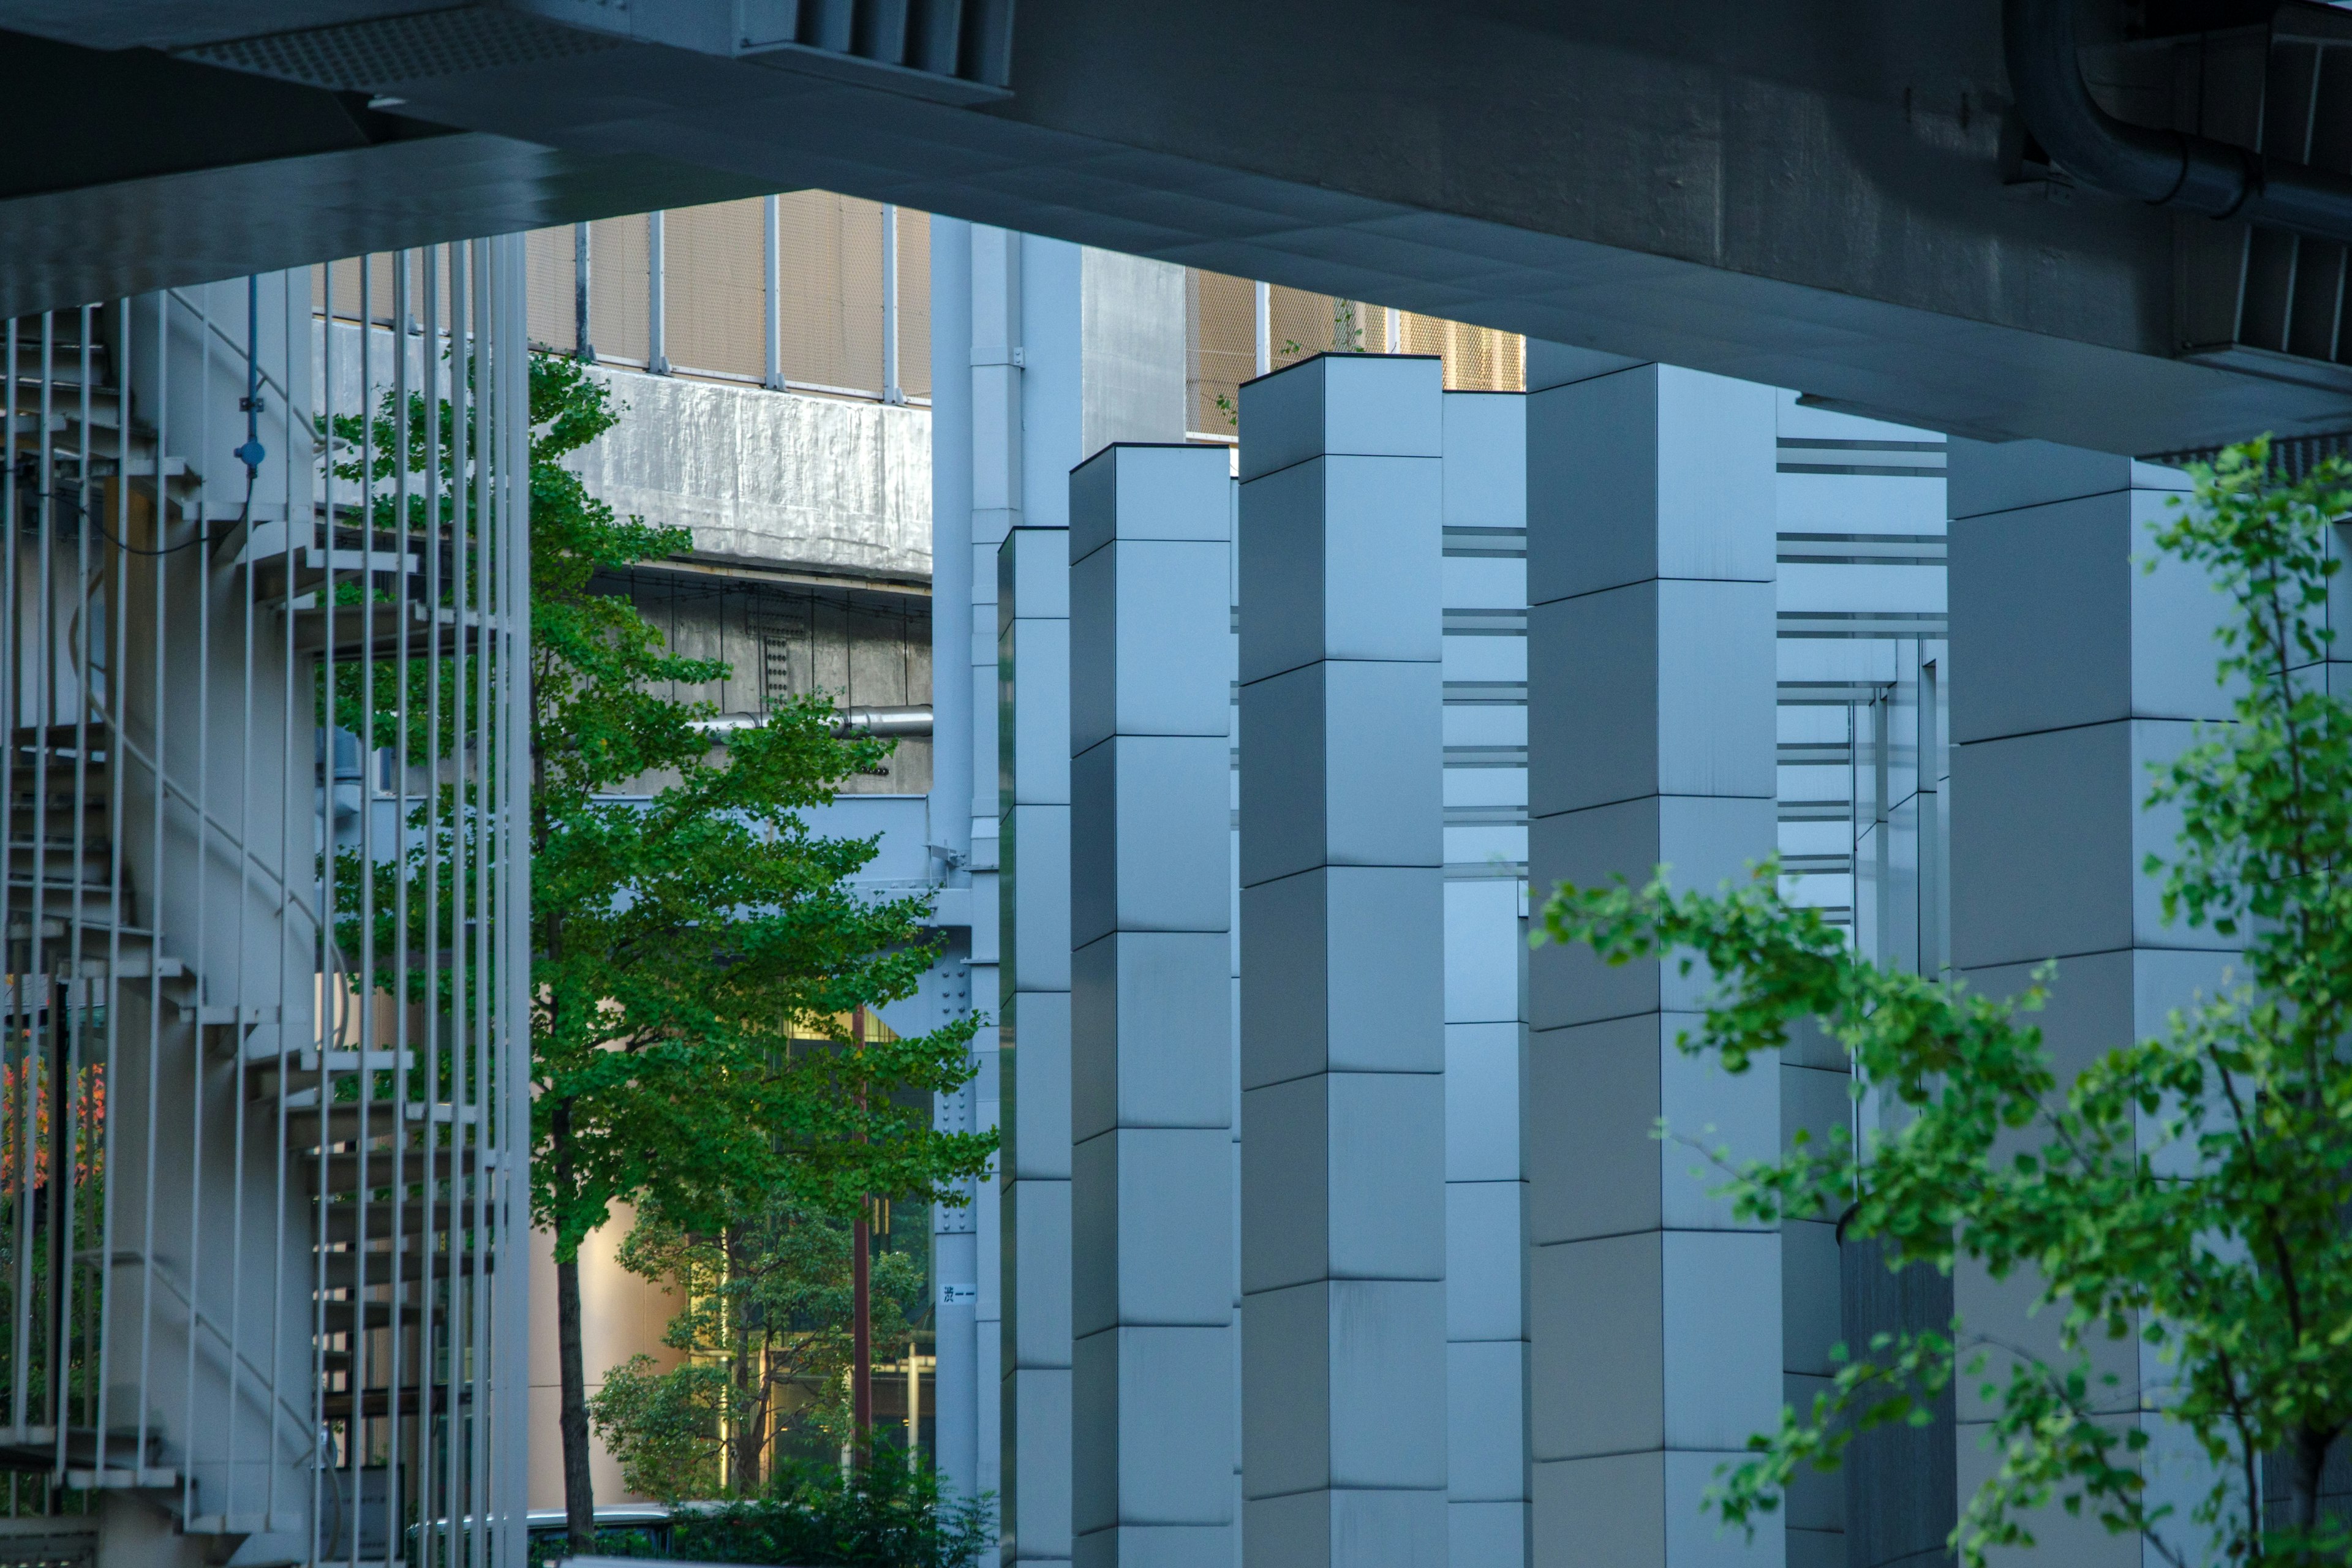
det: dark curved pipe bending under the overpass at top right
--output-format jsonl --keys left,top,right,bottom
{"left": 2002, "top": 0, "right": 2352, "bottom": 244}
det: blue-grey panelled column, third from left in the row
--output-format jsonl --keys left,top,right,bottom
{"left": 1240, "top": 355, "right": 1447, "bottom": 1568}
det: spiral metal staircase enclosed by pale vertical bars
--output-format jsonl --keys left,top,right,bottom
{"left": 0, "top": 239, "right": 529, "bottom": 1568}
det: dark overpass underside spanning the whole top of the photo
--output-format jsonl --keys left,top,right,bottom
{"left": 0, "top": 0, "right": 2352, "bottom": 454}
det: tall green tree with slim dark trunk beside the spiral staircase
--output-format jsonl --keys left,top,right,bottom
{"left": 514, "top": 355, "right": 995, "bottom": 1551}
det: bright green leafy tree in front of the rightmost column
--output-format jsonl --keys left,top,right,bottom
{"left": 1538, "top": 442, "right": 2352, "bottom": 1568}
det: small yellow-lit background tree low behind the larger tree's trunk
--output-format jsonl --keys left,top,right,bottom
{"left": 590, "top": 1197, "right": 927, "bottom": 1502}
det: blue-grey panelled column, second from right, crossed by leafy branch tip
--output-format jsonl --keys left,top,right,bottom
{"left": 1521, "top": 360, "right": 1783, "bottom": 1568}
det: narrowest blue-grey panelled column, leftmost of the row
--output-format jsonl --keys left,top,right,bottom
{"left": 997, "top": 527, "right": 1070, "bottom": 1563}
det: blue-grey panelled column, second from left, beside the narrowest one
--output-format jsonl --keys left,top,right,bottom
{"left": 1070, "top": 444, "right": 1235, "bottom": 1568}
